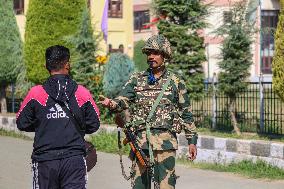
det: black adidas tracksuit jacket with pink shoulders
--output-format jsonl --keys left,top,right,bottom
{"left": 16, "top": 75, "right": 100, "bottom": 162}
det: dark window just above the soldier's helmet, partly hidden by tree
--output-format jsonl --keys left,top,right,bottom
{"left": 134, "top": 10, "right": 150, "bottom": 31}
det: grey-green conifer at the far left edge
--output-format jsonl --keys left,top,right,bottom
{"left": 0, "top": 0, "right": 23, "bottom": 113}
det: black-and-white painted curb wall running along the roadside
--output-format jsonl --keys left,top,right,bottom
{"left": 0, "top": 116, "right": 284, "bottom": 169}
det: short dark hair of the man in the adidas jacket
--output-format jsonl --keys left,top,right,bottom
{"left": 45, "top": 45, "right": 70, "bottom": 72}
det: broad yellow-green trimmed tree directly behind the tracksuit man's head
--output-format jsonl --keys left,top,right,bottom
{"left": 24, "top": 0, "right": 87, "bottom": 83}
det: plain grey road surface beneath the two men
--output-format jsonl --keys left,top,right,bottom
{"left": 0, "top": 136, "right": 284, "bottom": 189}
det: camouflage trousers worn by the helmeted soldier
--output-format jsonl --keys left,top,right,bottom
{"left": 133, "top": 150, "right": 176, "bottom": 189}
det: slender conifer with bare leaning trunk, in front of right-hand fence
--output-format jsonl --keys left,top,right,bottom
{"left": 218, "top": 1, "right": 254, "bottom": 135}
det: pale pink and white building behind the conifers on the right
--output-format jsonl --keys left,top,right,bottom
{"left": 133, "top": 0, "right": 280, "bottom": 81}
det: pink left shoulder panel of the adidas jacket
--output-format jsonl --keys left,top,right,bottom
{"left": 17, "top": 85, "right": 48, "bottom": 118}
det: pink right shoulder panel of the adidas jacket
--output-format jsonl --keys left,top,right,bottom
{"left": 75, "top": 85, "right": 100, "bottom": 119}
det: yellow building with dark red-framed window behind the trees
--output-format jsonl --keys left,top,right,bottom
{"left": 89, "top": 0, "right": 134, "bottom": 57}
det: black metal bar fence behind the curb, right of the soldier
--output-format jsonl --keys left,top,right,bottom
{"left": 191, "top": 82, "right": 284, "bottom": 134}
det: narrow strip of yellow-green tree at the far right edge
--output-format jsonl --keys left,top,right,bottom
{"left": 272, "top": 0, "right": 284, "bottom": 101}
